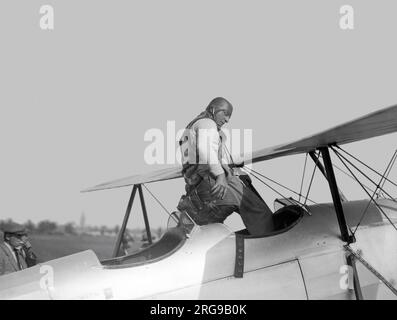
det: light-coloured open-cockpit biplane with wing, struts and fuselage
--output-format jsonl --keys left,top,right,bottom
{"left": 0, "top": 105, "right": 397, "bottom": 300}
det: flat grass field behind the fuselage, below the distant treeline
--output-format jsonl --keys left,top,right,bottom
{"left": 29, "top": 234, "right": 141, "bottom": 262}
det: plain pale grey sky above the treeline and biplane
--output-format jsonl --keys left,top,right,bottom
{"left": 0, "top": 0, "right": 397, "bottom": 227}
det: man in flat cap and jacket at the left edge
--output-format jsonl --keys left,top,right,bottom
{"left": 0, "top": 223, "right": 37, "bottom": 276}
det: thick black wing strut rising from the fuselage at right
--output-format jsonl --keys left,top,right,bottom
{"left": 319, "top": 147, "right": 355, "bottom": 244}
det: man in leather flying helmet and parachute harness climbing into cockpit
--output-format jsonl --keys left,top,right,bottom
{"left": 178, "top": 97, "right": 273, "bottom": 236}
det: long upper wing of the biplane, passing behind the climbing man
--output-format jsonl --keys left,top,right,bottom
{"left": 83, "top": 105, "right": 397, "bottom": 192}
